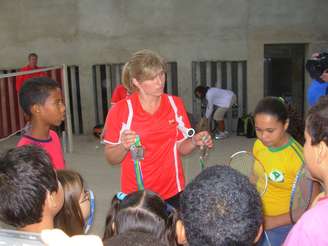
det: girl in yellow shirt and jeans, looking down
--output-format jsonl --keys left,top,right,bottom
{"left": 253, "top": 97, "right": 304, "bottom": 246}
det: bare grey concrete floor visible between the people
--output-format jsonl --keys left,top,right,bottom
{"left": 0, "top": 136, "right": 255, "bottom": 236}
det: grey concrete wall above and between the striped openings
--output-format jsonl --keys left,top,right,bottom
{"left": 0, "top": 0, "right": 328, "bottom": 134}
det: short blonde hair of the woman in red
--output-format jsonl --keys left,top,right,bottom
{"left": 122, "top": 50, "right": 166, "bottom": 93}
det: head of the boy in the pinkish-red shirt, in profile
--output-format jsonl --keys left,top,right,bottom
{"left": 19, "top": 77, "right": 65, "bottom": 126}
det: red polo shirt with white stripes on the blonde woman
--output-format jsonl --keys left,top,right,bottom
{"left": 104, "top": 93, "right": 190, "bottom": 199}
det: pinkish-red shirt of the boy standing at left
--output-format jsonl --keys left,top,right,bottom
{"left": 16, "top": 130, "right": 65, "bottom": 170}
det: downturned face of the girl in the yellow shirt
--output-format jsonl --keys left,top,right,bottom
{"left": 255, "top": 113, "right": 288, "bottom": 148}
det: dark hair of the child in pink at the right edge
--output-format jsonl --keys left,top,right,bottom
{"left": 306, "top": 96, "right": 328, "bottom": 145}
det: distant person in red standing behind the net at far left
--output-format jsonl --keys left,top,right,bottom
{"left": 16, "top": 53, "right": 47, "bottom": 94}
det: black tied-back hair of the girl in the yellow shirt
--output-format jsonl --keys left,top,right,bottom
{"left": 254, "top": 97, "right": 305, "bottom": 145}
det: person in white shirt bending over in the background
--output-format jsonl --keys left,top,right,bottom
{"left": 194, "top": 86, "right": 236, "bottom": 139}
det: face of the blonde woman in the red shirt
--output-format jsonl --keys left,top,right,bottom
{"left": 133, "top": 70, "right": 165, "bottom": 96}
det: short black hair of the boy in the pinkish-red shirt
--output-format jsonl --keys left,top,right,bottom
{"left": 19, "top": 77, "right": 60, "bottom": 116}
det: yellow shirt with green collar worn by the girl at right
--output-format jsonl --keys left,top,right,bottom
{"left": 253, "top": 137, "right": 303, "bottom": 216}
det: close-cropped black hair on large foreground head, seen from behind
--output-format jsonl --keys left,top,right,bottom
{"left": 180, "top": 165, "right": 263, "bottom": 246}
